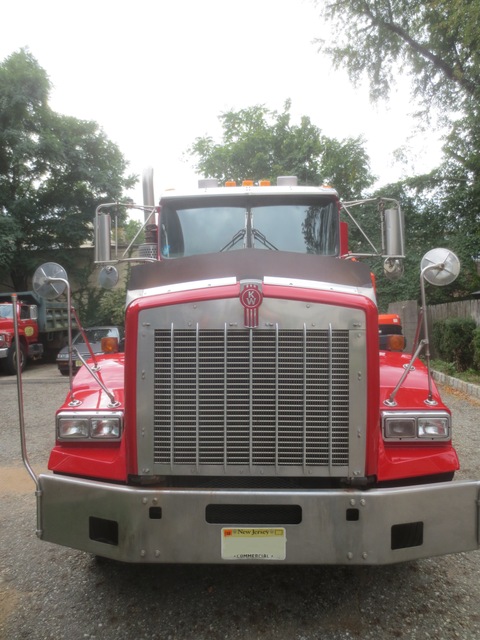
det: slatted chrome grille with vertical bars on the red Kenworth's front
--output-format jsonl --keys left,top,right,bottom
{"left": 153, "top": 325, "right": 350, "bottom": 475}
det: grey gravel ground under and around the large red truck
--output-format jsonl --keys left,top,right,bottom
{"left": 0, "top": 365, "right": 480, "bottom": 640}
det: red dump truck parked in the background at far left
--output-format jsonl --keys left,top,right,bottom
{"left": 0, "top": 291, "right": 68, "bottom": 374}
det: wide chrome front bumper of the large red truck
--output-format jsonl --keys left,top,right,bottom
{"left": 38, "top": 474, "right": 480, "bottom": 565}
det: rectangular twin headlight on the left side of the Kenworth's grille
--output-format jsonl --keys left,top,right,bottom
{"left": 57, "top": 411, "right": 123, "bottom": 440}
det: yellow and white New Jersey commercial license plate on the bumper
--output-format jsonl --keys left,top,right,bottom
{"left": 222, "top": 527, "right": 287, "bottom": 561}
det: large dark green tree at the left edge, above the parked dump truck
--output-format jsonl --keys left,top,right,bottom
{"left": 0, "top": 50, "right": 136, "bottom": 290}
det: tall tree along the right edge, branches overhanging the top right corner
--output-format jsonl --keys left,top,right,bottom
{"left": 317, "top": 0, "right": 480, "bottom": 297}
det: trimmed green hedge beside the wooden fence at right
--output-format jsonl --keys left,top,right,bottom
{"left": 432, "top": 318, "right": 476, "bottom": 371}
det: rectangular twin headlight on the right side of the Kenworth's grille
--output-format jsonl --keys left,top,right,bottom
{"left": 382, "top": 411, "right": 451, "bottom": 442}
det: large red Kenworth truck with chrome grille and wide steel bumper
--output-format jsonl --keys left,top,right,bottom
{"left": 22, "top": 173, "right": 480, "bottom": 565}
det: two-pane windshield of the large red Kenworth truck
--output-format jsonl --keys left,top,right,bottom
{"left": 160, "top": 196, "right": 339, "bottom": 258}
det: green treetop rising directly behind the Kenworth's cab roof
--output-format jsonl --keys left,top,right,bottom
{"left": 188, "top": 100, "right": 373, "bottom": 199}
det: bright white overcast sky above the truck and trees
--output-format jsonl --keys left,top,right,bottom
{"left": 0, "top": 0, "right": 440, "bottom": 211}
